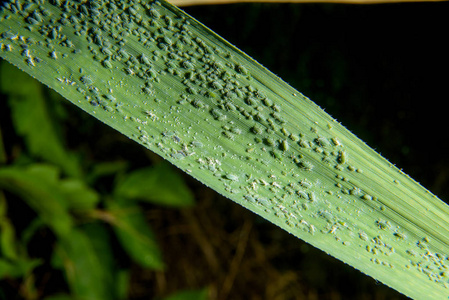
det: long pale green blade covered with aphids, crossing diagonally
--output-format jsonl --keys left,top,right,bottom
{"left": 0, "top": 0, "right": 449, "bottom": 299}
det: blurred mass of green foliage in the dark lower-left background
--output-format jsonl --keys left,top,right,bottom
{"left": 0, "top": 61, "right": 200, "bottom": 300}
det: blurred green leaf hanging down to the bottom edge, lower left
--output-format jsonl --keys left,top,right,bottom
{"left": 54, "top": 229, "right": 112, "bottom": 300}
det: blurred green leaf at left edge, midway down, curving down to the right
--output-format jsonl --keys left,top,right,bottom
{"left": 0, "top": 164, "right": 72, "bottom": 236}
